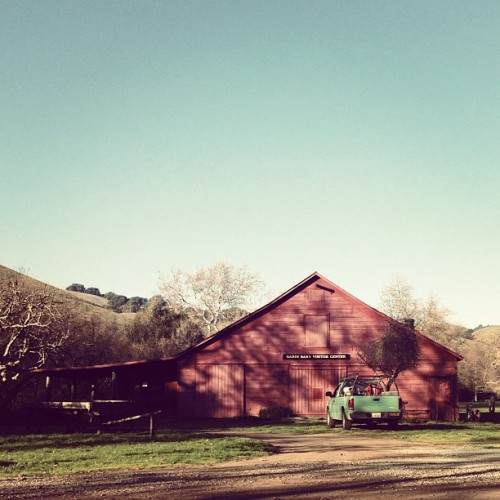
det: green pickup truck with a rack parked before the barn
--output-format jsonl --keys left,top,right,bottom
{"left": 326, "top": 375, "right": 402, "bottom": 430}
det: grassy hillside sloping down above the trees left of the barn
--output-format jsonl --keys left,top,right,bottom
{"left": 0, "top": 265, "right": 135, "bottom": 324}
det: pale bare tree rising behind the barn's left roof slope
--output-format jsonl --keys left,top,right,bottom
{"left": 160, "top": 262, "right": 262, "bottom": 336}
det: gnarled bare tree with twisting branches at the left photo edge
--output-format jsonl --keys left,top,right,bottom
{"left": 0, "top": 278, "right": 69, "bottom": 383}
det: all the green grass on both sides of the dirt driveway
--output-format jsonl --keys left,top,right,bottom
{"left": 0, "top": 419, "right": 500, "bottom": 477}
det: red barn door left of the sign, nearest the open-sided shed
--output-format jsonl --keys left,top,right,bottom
{"left": 195, "top": 365, "right": 243, "bottom": 418}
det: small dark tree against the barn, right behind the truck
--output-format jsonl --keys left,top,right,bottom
{"left": 355, "top": 321, "right": 420, "bottom": 391}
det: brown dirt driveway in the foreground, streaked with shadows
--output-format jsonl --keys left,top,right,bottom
{"left": 0, "top": 433, "right": 500, "bottom": 500}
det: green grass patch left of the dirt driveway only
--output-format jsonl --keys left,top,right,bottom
{"left": 0, "top": 431, "right": 273, "bottom": 476}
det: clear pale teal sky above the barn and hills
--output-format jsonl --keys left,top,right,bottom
{"left": 0, "top": 0, "right": 500, "bottom": 327}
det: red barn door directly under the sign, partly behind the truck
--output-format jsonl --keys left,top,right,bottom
{"left": 290, "top": 366, "right": 346, "bottom": 415}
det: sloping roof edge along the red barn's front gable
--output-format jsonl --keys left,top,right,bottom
{"left": 176, "top": 272, "right": 463, "bottom": 361}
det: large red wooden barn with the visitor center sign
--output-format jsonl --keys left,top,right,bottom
{"left": 177, "top": 273, "right": 462, "bottom": 420}
